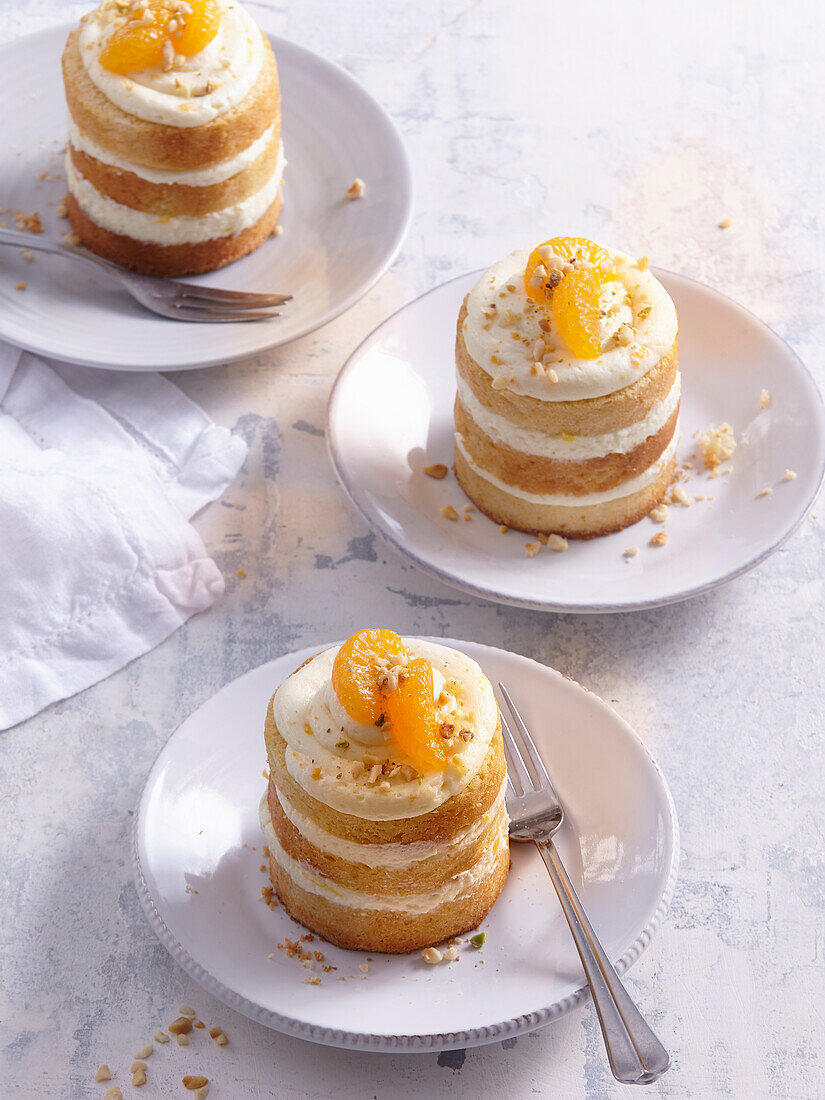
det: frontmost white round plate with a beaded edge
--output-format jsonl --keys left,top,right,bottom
{"left": 133, "top": 638, "right": 679, "bottom": 1051}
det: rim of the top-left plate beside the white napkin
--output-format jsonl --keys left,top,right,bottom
{"left": 0, "top": 20, "right": 416, "bottom": 372}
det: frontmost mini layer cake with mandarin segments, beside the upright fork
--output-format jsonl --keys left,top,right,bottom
{"left": 261, "top": 630, "right": 509, "bottom": 953}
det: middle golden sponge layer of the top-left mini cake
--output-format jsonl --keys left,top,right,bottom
{"left": 69, "top": 125, "right": 281, "bottom": 218}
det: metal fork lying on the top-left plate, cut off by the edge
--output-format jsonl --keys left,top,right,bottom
{"left": 0, "top": 227, "right": 292, "bottom": 323}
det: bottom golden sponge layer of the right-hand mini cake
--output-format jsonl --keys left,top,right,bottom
{"left": 455, "top": 448, "right": 675, "bottom": 539}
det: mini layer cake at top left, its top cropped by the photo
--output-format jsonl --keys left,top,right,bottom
{"left": 63, "top": 0, "right": 285, "bottom": 275}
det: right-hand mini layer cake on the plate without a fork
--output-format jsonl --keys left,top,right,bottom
{"left": 454, "top": 238, "right": 681, "bottom": 538}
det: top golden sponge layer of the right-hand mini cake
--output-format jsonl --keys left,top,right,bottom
{"left": 455, "top": 299, "right": 679, "bottom": 436}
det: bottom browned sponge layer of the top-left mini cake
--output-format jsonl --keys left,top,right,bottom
{"left": 66, "top": 191, "right": 282, "bottom": 276}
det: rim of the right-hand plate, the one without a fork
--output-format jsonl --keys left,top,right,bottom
{"left": 325, "top": 265, "right": 825, "bottom": 615}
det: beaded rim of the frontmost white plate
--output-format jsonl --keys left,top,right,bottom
{"left": 130, "top": 635, "right": 681, "bottom": 1054}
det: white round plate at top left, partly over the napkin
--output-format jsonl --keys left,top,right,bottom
{"left": 0, "top": 26, "right": 413, "bottom": 371}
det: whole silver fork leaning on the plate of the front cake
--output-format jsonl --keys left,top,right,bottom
{"left": 498, "top": 682, "right": 670, "bottom": 1085}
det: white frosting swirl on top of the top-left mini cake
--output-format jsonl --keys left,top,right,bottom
{"left": 79, "top": 0, "right": 264, "bottom": 128}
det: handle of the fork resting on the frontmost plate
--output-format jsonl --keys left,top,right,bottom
{"left": 536, "top": 837, "right": 670, "bottom": 1085}
